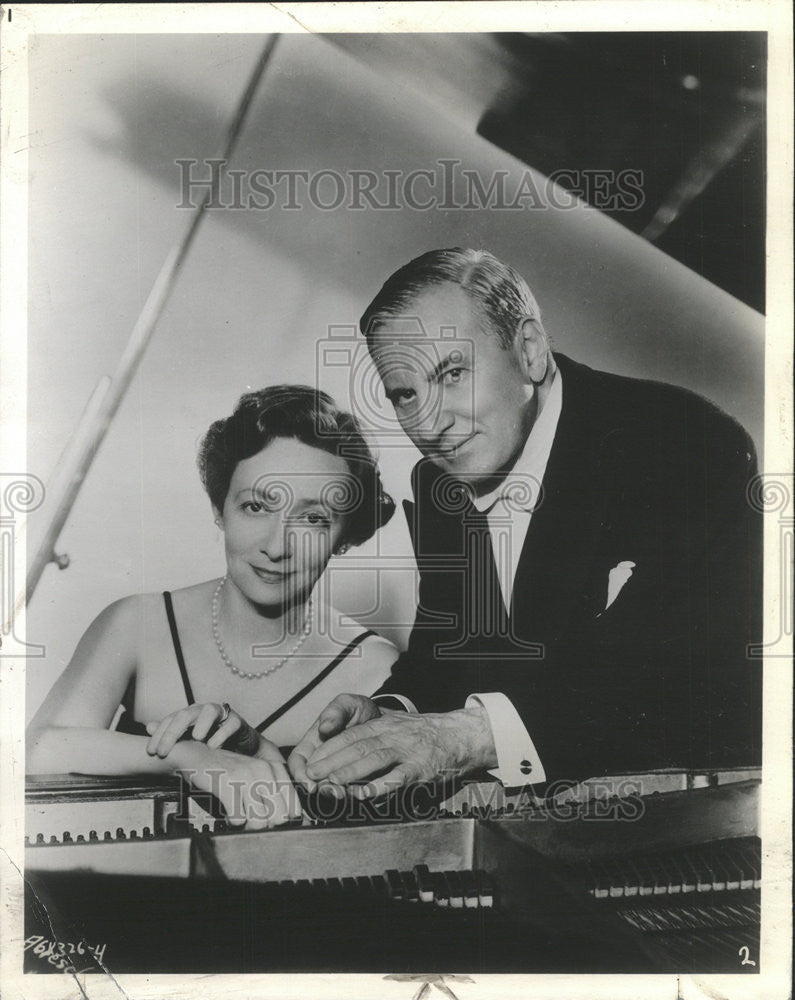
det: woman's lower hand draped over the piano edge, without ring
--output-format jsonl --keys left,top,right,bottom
{"left": 170, "top": 740, "right": 302, "bottom": 830}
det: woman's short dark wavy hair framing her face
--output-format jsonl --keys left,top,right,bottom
{"left": 198, "top": 385, "right": 395, "bottom": 545}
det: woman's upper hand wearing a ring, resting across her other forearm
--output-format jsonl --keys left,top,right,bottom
{"left": 146, "top": 702, "right": 262, "bottom": 759}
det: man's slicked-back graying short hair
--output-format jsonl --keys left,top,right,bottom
{"left": 359, "top": 247, "right": 541, "bottom": 347}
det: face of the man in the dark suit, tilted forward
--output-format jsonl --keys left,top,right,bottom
{"left": 372, "top": 283, "right": 536, "bottom": 492}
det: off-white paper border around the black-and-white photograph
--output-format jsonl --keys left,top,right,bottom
{"left": 0, "top": 0, "right": 793, "bottom": 1000}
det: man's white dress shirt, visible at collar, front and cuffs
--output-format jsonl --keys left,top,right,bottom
{"left": 384, "top": 370, "right": 563, "bottom": 786}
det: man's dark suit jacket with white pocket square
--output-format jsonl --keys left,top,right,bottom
{"left": 379, "top": 355, "right": 762, "bottom": 781}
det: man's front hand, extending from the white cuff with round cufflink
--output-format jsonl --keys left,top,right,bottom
{"left": 296, "top": 706, "right": 497, "bottom": 798}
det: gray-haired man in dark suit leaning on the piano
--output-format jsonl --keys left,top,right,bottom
{"left": 290, "top": 249, "right": 761, "bottom": 797}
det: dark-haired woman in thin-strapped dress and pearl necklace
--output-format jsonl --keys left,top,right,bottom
{"left": 28, "top": 386, "right": 397, "bottom": 827}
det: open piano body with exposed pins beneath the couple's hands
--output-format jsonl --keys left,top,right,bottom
{"left": 24, "top": 769, "right": 761, "bottom": 973}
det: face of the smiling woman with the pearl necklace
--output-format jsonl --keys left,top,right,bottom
{"left": 218, "top": 438, "right": 353, "bottom": 607}
